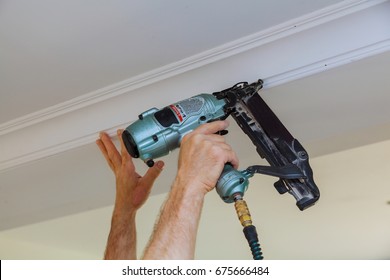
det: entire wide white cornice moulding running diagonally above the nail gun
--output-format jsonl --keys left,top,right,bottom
{"left": 0, "top": 1, "right": 390, "bottom": 171}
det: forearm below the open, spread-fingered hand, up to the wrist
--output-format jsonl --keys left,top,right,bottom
{"left": 104, "top": 209, "right": 137, "bottom": 260}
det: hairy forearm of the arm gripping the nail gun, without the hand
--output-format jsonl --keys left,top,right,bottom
{"left": 143, "top": 177, "right": 205, "bottom": 259}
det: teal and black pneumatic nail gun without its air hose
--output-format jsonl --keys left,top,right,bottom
{"left": 123, "top": 80, "right": 320, "bottom": 210}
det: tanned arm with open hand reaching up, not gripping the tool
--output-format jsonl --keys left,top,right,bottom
{"left": 96, "top": 130, "right": 164, "bottom": 260}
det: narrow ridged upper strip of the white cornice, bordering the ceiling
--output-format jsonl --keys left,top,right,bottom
{"left": 0, "top": 0, "right": 388, "bottom": 136}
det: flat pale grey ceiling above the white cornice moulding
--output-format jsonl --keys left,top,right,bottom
{"left": 0, "top": 0, "right": 340, "bottom": 123}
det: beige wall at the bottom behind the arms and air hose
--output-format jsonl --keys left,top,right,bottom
{"left": 0, "top": 141, "right": 390, "bottom": 259}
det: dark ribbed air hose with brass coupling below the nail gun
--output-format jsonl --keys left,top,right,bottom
{"left": 234, "top": 194, "right": 263, "bottom": 260}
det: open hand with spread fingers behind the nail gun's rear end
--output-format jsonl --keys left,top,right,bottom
{"left": 96, "top": 130, "right": 164, "bottom": 212}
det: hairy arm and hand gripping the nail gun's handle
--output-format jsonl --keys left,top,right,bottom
{"left": 143, "top": 121, "right": 238, "bottom": 259}
